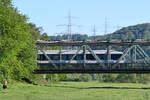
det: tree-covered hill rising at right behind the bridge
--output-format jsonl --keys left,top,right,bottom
{"left": 96, "top": 23, "right": 150, "bottom": 39}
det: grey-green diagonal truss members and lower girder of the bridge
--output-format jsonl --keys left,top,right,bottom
{"left": 37, "top": 41, "right": 150, "bottom": 73}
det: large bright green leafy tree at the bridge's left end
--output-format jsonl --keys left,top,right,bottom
{"left": 0, "top": 0, "right": 36, "bottom": 81}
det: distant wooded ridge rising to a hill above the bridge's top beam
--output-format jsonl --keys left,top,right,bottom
{"left": 50, "top": 23, "right": 150, "bottom": 40}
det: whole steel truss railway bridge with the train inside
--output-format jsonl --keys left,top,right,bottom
{"left": 35, "top": 39, "right": 150, "bottom": 74}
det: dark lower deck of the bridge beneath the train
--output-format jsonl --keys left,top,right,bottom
{"left": 35, "top": 63, "right": 150, "bottom": 74}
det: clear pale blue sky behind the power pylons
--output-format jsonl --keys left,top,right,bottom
{"left": 13, "top": 0, "right": 150, "bottom": 35}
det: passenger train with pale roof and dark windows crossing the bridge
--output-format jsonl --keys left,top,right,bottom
{"left": 38, "top": 50, "right": 124, "bottom": 63}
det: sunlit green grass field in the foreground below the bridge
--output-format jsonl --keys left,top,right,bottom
{"left": 0, "top": 82, "right": 150, "bottom": 100}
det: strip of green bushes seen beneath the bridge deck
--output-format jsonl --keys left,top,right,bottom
{"left": 41, "top": 74, "right": 150, "bottom": 84}
